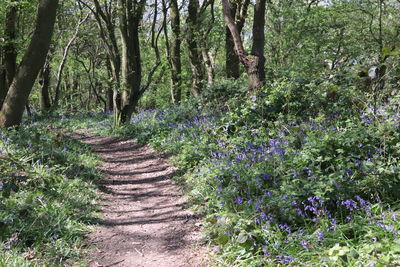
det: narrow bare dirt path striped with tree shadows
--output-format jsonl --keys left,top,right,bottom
{"left": 73, "top": 134, "right": 207, "bottom": 267}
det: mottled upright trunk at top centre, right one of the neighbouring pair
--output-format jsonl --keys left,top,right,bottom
{"left": 187, "top": 0, "right": 204, "bottom": 98}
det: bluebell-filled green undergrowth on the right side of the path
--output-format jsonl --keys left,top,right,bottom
{"left": 104, "top": 89, "right": 400, "bottom": 266}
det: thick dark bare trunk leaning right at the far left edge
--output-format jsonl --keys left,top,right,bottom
{"left": 0, "top": 0, "right": 58, "bottom": 127}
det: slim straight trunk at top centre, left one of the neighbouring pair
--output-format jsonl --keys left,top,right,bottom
{"left": 170, "top": 0, "right": 182, "bottom": 104}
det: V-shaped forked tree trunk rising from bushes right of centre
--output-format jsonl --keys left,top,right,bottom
{"left": 222, "top": 0, "right": 270, "bottom": 93}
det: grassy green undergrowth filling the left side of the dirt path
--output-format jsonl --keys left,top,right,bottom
{"left": 0, "top": 123, "right": 100, "bottom": 266}
